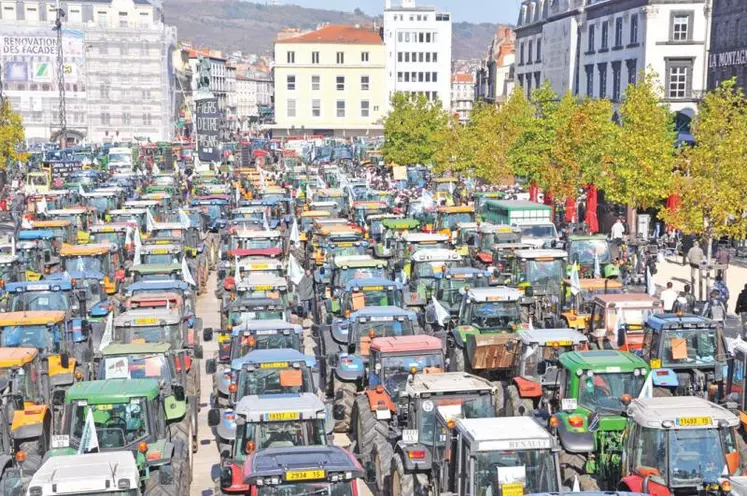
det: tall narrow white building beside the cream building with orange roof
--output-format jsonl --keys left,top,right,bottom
{"left": 384, "top": 0, "right": 451, "bottom": 110}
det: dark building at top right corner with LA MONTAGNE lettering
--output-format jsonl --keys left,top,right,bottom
{"left": 708, "top": 0, "right": 747, "bottom": 89}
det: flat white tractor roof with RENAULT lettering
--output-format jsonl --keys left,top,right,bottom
{"left": 455, "top": 417, "right": 553, "bottom": 451}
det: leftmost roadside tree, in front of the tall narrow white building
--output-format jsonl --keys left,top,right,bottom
{"left": 383, "top": 92, "right": 449, "bottom": 165}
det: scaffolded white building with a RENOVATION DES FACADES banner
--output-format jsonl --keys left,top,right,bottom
{"left": 0, "top": 0, "right": 176, "bottom": 143}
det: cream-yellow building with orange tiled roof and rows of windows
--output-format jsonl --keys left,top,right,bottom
{"left": 271, "top": 25, "right": 386, "bottom": 136}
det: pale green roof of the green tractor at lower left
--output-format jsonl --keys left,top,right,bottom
{"left": 66, "top": 379, "right": 160, "bottom": 404}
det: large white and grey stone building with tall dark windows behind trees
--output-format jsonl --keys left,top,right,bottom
{"left": 516, "top": 0, "right": 710, "bottom": 121}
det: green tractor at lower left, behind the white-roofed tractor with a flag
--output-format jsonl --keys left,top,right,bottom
{"left": 50, "top": 379, "right": 192, "bottom": 496}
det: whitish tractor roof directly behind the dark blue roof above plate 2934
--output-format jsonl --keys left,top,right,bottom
{"left": 235, "top": 393, "right": 327, "bottom": 422}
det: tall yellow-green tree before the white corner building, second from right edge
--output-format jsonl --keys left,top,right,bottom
{"left": 599, "top": 71, "right": 675, "bottom": 208}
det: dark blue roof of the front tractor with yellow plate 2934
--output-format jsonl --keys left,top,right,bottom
{"left": 244, "top": 446, "right": 365, "bottom": 482}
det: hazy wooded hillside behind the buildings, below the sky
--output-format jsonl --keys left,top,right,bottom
{"left": 164, "top": 0, "right": 496, "bottom": 59}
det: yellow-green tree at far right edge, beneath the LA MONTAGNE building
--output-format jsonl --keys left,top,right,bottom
{"left": 662, "top": 79, "right": 747, "bottom": 256}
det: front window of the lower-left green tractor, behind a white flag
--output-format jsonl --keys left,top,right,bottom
{"left": 70, "top": 398, "right": 148, "bottom": 450}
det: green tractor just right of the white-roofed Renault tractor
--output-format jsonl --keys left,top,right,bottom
{"left": 550, "top": 350, "right": 649, "bottom": 491}
